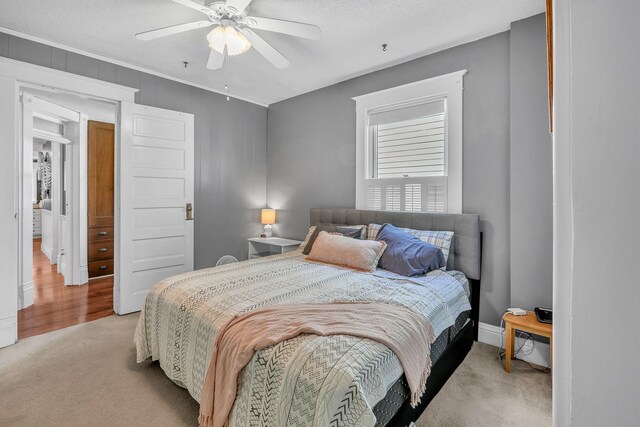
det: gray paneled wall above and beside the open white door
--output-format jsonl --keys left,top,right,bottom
{"left": 0, "top": 33, "right": 267, "bottom": 268}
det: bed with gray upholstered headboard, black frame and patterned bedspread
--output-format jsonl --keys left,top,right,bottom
{"left": 135, "top": 209, "right": 481, "bottom": 427}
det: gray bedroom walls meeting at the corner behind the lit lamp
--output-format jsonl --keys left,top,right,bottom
{"left": 0, "top": 16, "right": 551, "bottom": 324}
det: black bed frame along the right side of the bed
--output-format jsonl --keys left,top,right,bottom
{"left": 386, "top": 233, "right": 482, "bottom": 427}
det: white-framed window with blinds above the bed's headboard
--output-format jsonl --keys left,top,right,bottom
{"left": 354, "top": 70, "right": 466, "bottom": 213}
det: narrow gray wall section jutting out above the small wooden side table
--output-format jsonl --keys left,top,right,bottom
{"left": 510, "top": 14, "right": 553, "bottom": 309}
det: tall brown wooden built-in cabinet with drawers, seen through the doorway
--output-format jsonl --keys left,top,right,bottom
{"left": 87, "top": 120, "right": 115, "bottom": 277}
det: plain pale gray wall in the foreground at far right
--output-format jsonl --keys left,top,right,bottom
{"left": 553, "top": 0, "right": 640, "bottom": 427}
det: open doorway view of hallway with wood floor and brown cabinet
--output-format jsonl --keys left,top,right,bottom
{"left": 17, "top": 88, "right": 117, "bottom": 339}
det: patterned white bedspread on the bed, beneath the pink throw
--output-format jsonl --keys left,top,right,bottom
{"left": 135, "top": 251, "right": 471, "bottom": 427}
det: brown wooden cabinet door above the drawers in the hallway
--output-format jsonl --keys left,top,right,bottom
{"left": 87, "top": 121, "right": 115, "bottom": 228}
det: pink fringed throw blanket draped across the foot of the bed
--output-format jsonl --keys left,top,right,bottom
{"left": 199, "top": 302, "right": 435, "bottom": 427}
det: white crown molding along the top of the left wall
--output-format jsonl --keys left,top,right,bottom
{"left": 0, "top": 26, "right": 269, "bottom": 107}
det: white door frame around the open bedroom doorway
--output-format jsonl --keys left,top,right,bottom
{"left": 0, "top": 58, "right": 138, "bottom": 347}
